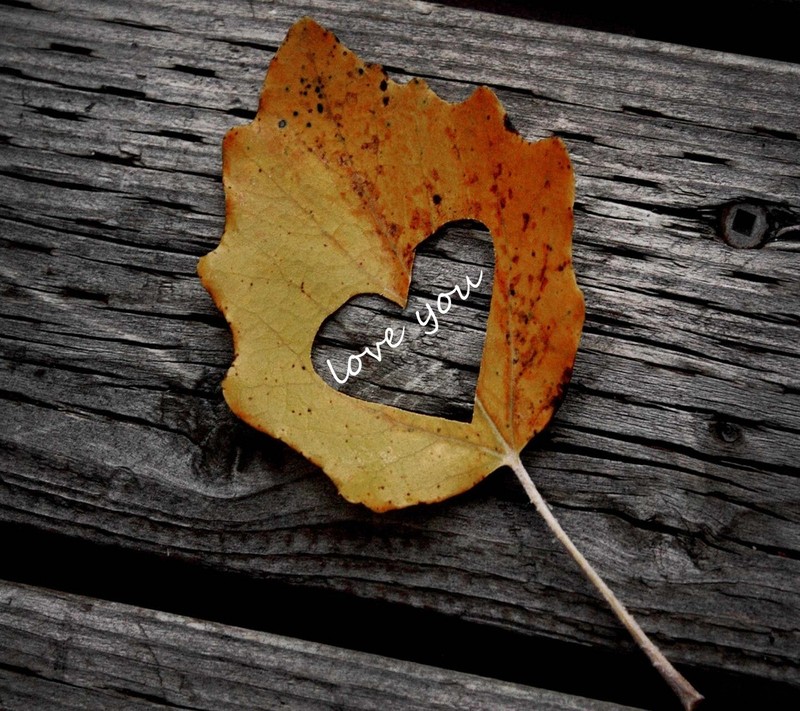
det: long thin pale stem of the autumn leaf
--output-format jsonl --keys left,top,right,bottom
{"left": 507, "top": 453, "right": 703, "bottom": 711}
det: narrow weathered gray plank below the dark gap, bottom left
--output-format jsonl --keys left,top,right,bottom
{"left": 0, "top": 582, "right": 631, "bottom": 711}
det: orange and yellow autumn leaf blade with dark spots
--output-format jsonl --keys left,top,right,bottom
{"left": 199, "top": 19, "right": 584, "bottom": 511}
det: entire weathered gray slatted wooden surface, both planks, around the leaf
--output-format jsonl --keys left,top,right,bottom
{"left": 0, "top": 0, "right": 800, "bottom": 710}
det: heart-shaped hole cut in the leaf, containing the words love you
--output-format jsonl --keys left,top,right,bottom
{"left": 311, "top": 220, "right": 494, "bottom": 422}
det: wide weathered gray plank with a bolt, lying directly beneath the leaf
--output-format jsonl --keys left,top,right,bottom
{"left": 0, "top": 0, "right": 800, "bottom": 708}
